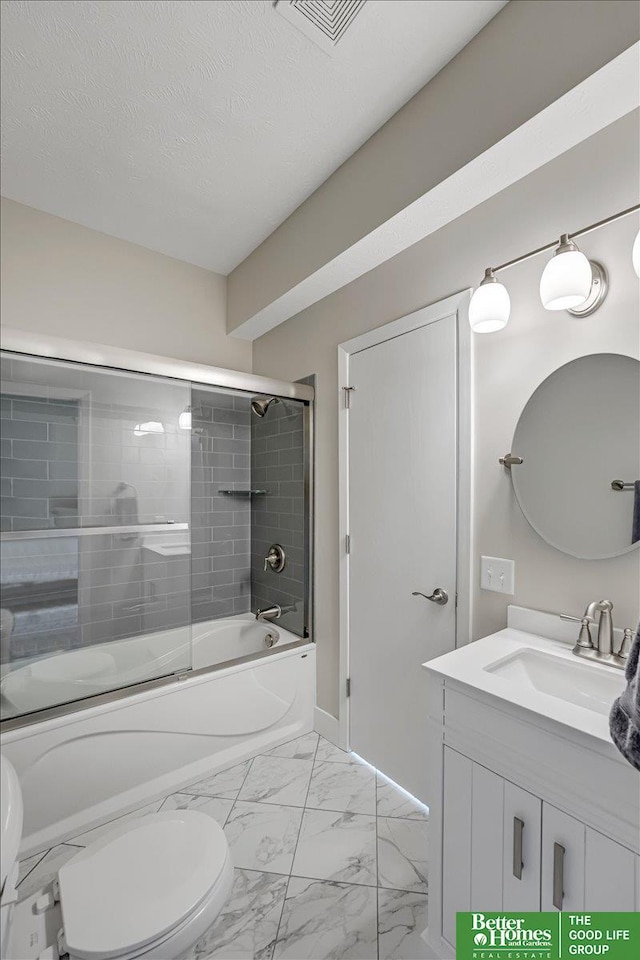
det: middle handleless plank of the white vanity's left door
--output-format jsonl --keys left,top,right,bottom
{"left": 470, "top": 763, "right": 505, "bottom": 912}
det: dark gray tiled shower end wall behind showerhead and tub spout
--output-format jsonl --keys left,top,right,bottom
{"left": 251, "top": 400, "right": 305, "bottom": 636}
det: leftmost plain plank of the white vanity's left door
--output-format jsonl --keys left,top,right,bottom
{"left": 442, "top": 747, "right": 473, "bottom": 946}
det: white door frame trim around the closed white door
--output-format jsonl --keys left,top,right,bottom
{"left": 338, "top": 289, "right": 473, "bottom": 750}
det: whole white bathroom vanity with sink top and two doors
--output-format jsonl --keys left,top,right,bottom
{"left": 424, "top": 608, "right": 640, "bottom": 957}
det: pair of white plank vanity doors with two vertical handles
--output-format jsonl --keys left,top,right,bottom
{"left": 442, "top": 746, "right": 640, "bottom": 946}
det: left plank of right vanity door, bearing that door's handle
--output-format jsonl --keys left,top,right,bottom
{"left": 541, "top": 803, "right": 585, "bottom": 911}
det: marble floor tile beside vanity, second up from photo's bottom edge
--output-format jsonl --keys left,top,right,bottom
{"left": 377, "top": 817, "right": 429, "bottom": 893}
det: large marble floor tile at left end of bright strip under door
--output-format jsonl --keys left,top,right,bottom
{"left": 307, "top": 760, "right": 376, "bottom": 816}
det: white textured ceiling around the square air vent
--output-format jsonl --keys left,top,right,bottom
{"left": 2, "top": 0, "right": 504, "bottom": 273}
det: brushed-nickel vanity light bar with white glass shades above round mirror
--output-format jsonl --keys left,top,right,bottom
{"left": 469, "top": 204, "right": 640, "bottom": 333}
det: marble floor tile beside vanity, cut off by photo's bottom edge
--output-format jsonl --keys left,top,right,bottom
{"left": 378, "top": 890, "right": 434, "bottom": 960}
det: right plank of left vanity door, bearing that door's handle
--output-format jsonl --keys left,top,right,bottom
{"left": 502, "top": 780, "right": 542, "bottom": 912}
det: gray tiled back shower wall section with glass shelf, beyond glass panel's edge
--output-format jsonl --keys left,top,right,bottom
{"left": 191, "top": 389, "right": 252, "bottom": 622}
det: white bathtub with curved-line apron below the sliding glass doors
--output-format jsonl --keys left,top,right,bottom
{"left": 0, "top": 614, "right": 315, "bottom": 857}
